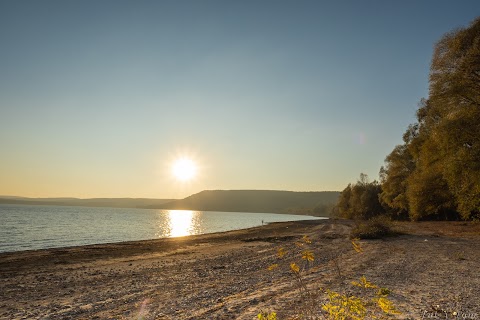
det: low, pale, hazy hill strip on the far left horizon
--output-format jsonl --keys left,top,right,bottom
{"left": 0, "top": 196, "right": 174, "bottom": 208}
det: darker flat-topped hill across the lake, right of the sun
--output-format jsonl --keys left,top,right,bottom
{"left": 156, "top": 190, "right": 340, "bottom": 216}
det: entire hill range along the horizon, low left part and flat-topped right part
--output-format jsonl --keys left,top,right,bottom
{"left": 0, "top": 190, "right": 340, "bottom": 217}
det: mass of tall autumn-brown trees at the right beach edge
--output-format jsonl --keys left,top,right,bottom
{"left": 380, "top": 19, "right": 480, "bottom": 220}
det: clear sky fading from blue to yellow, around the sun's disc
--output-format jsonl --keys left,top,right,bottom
{"left": 0, "top": 0, "right": 480, "bottom": 198}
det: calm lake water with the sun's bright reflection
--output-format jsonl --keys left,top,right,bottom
{"left": 0, "top": 204, "right": 326, "bottom": 252}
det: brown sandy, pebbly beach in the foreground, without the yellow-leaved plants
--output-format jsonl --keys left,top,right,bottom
{"left": 0, "top": 220, "right": 480, "bottom": 319}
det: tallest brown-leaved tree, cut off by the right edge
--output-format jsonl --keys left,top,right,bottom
{"left": 429, "top": 18, "right": 480, "bottom": 218}
